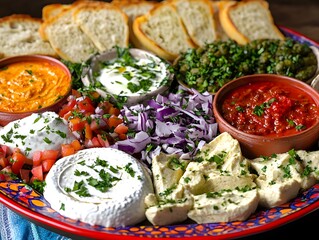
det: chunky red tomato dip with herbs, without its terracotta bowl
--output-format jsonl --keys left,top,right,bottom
{"left": 222, "top": 81, "right": 319, "bottom": 136}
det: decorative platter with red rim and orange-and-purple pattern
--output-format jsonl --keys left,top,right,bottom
{"left": 0, "top": 27, "right": 319, "bottom": 240}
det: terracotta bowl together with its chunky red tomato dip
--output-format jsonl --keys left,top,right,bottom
{"left": 213, "top": 74, "right": 319, "bottom": 159}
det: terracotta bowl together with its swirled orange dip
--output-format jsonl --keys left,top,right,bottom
{"left": 0, "top": 55, "right": 72, "bottom": 126}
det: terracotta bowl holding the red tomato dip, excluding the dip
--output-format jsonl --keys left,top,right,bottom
{"left": 213, "top": 74, "right": 319, "bottom": 159}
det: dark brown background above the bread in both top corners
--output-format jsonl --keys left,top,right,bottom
{"left": 0, "top": 0, "right": 319, "bottom": 42}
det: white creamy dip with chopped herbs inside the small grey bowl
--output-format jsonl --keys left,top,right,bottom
{"left": 95, "top": 48, "right": 168, "bottom": 96}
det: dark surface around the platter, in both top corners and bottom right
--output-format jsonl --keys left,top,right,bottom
{"left": 0, "top": 0, "right": 319, "bottom": 240}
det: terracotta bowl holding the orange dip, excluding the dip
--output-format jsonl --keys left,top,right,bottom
{"left": 0, "top": 55, "right": 72, "bottom": 126}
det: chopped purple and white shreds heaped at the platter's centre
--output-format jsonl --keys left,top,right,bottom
{"left": 112, "top": 90, "right": 217, "bottom": 164}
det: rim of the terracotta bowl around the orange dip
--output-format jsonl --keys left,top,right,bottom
{"left": 0, "top": 54, "right": 72, "bottom": 117}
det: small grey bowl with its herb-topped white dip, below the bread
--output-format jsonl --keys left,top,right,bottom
{"left": 82, "top": 48, "right": 173, "bottom": 106}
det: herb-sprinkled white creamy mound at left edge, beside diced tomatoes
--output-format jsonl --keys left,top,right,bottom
{"left": 0, "top": 112, "right": 75, "bottom": 158}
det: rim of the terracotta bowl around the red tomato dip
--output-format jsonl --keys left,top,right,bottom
{"left": 212, "top": 73, "right": 319, "bottom": 141}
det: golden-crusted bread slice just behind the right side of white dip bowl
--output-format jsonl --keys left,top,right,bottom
{"left": 133, "top": 2, "right": 195, "bottom": 61}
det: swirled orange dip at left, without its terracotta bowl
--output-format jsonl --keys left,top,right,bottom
{"left": 0, "top": 60, "right": 71, "bottom": 113}
